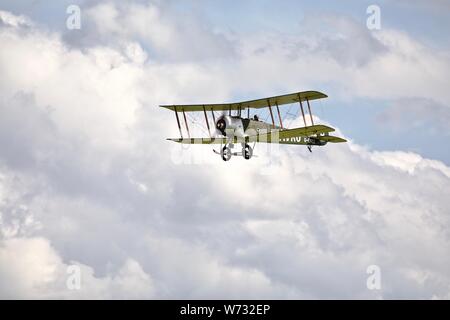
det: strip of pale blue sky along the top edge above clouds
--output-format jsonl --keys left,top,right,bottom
{"left": 5, "top": 0, "right": 450, "bottom": 48}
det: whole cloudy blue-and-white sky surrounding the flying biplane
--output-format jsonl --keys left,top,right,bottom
{"left": 0, "top": 0, "right": 450, "bottom": 299}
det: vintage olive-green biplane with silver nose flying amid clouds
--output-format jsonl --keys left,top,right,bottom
{"left": 160, "top": 91, "right": 347, "bottom": 161}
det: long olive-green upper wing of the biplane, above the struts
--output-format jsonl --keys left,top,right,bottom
{"left": 160, "top": 91, "right": 328, "bottom": 112}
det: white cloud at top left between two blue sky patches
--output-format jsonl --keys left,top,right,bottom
{"left": 65, "top": 1, "right": 239, "bottom": 61}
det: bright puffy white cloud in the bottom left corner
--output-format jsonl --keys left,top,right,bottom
{"left": 0, "top": 238, "right": 154, "bottom": 299}
